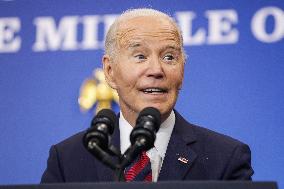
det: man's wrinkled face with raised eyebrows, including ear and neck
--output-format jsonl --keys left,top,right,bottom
{"left": 104, "top": 16, "right": 184, "bottom": 125}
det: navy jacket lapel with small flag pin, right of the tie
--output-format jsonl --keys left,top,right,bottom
{"left": 158, "top": 111, "right": 197, "bottom": 181}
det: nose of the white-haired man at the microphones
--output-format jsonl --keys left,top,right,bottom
{"left": 147, "top": 57, "right": 165, "bottom": 79}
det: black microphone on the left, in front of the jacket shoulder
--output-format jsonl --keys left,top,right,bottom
{"left": 83, "top": 109, "right": 117, "bottom": 169}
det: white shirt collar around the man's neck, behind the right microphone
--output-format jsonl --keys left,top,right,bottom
{"left": 119, "top": 111, "right": 175, "bottom": 158}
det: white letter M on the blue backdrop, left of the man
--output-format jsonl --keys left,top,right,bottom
{"left": 33, "top": 16, "right": 79, "bottom": 51}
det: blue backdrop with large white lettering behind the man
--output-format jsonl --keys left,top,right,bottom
{"left": 0, "top": 0, "right": 284, "bottom": 188}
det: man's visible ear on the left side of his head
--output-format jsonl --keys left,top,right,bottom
{"left": 102, "top": 55, "right": 116, "bottom": 89}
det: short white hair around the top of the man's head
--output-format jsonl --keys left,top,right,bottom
{"left": 105, "top": 8, "right": 186, "bottom": 61}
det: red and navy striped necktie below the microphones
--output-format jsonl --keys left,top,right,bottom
{"left": 125, "top": 152, "right": 152, "bottom": 182}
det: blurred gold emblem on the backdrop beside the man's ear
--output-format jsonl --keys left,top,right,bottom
{"left": 78, "top": 69, "right": 118, "bottom": 113}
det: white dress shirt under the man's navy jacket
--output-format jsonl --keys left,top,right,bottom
{"left": 119, "top": 111, "right": 175, "bottom": 182}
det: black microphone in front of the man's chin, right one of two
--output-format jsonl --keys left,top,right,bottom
{"left": 121, "top": 107, "right": 161, "bottom": 169}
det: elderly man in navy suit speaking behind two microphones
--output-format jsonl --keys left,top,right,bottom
{"left": 41, "top": 9, "right": 253, "bottom": 182}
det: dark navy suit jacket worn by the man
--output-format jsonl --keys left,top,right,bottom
{"left": 41, "top": 112, "right": 253, "bottom": 183}
